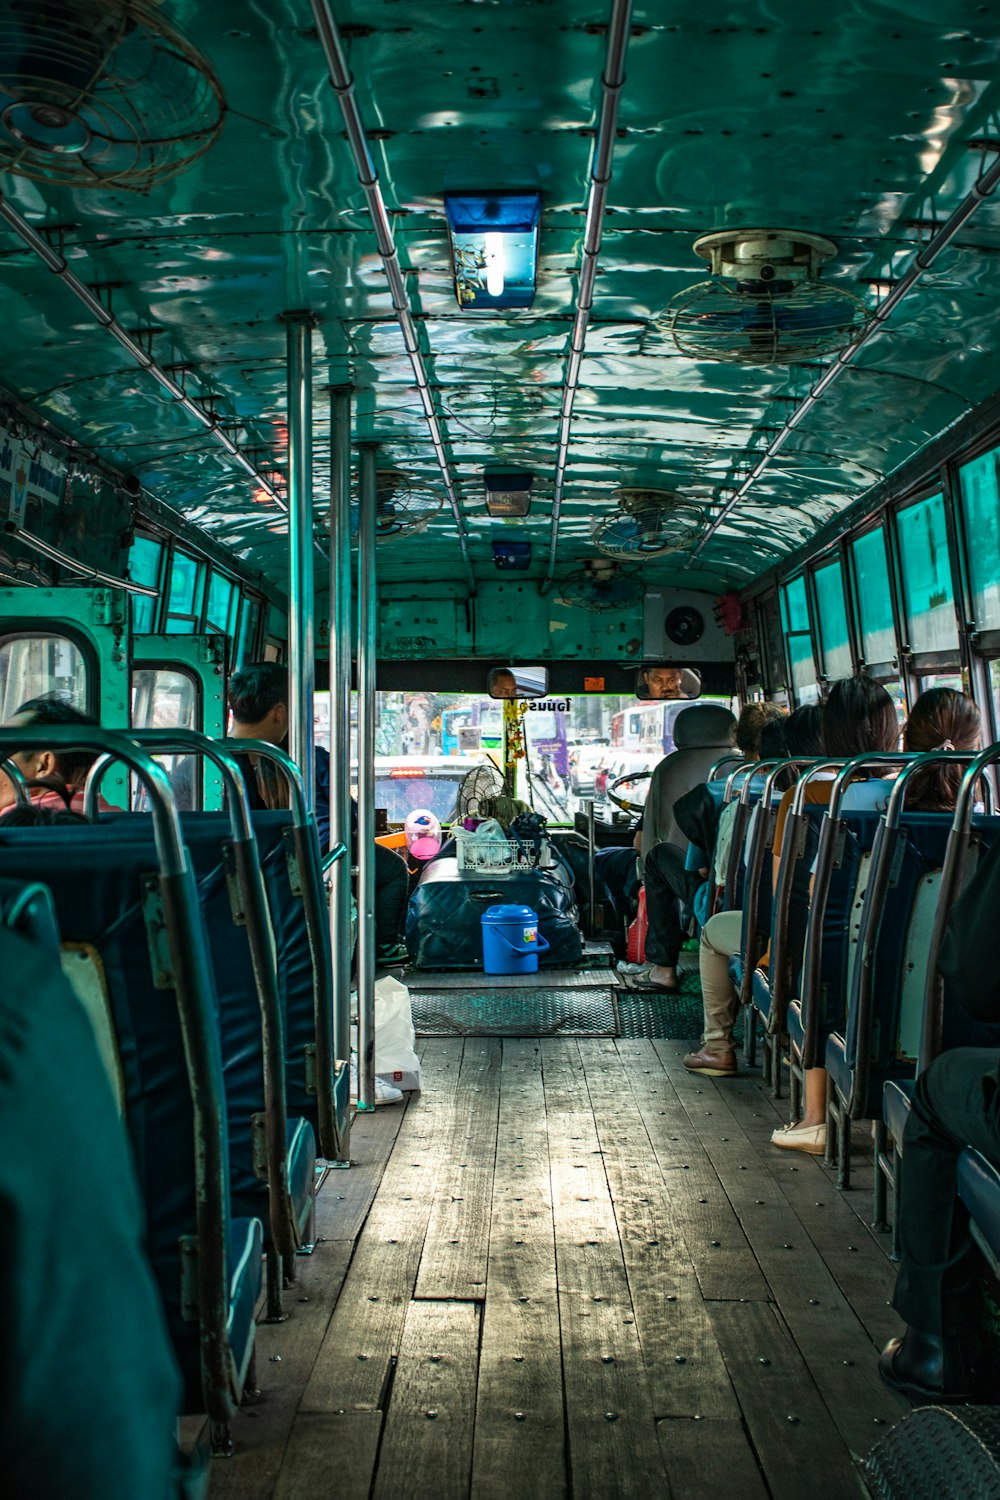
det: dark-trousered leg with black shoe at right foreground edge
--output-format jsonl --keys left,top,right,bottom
{"left": 879, "top": 1047, "right": 1000, "bottom": 1400}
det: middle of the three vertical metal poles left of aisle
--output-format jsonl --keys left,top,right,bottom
{"left": 330, "top": 386, "right": 354, "bottom": 1146}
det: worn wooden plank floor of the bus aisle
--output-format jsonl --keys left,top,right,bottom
{"left": 210, "top": 1038, "right": 907, "bottom": 1500}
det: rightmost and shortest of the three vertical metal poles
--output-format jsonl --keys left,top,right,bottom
{"left": 358, "top": 443, "right": 378, "bottom": 1110}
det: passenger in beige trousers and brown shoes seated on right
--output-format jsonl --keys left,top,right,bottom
{"left": 684, "top": 704, "right": 823, "bottom": 1079}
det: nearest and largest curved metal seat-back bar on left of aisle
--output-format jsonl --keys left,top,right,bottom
{"left": 0, "top": 725, "right": 238, "bottom": 1427}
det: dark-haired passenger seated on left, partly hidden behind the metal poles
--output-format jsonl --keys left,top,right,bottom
{"left": 229, "top": 662, "right": 409, "bottom": 963}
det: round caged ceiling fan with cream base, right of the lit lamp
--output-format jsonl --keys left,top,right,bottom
{"left": 664, "top": 230, "right": 873, "bottom": 365}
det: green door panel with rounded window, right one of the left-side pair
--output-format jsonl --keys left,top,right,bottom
{"left": 132, "top": 635, "right": 226, "bottom": 812}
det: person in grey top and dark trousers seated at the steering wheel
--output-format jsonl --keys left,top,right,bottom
{"left": 640, "top": 704, "right": 736, "bottom": 993}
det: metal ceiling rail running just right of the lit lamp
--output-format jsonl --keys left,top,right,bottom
{"left": 541, "top": 0, "right": 633, "bottom": 593}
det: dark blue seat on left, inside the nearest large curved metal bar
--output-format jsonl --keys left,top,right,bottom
{"left": 0, "top": 818, "right": 262, "bottom": 1424}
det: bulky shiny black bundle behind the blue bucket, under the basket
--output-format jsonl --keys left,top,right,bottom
{"left": 406, "top": 860, "right": 583, "bottom": 969}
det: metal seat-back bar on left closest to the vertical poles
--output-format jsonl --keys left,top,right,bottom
{"left": 217, "top": 740, "right": 344, "bottom": 1161}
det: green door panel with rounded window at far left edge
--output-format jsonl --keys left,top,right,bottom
{"left": 0, "top": 588, "right": 129, "bottom": 807}
